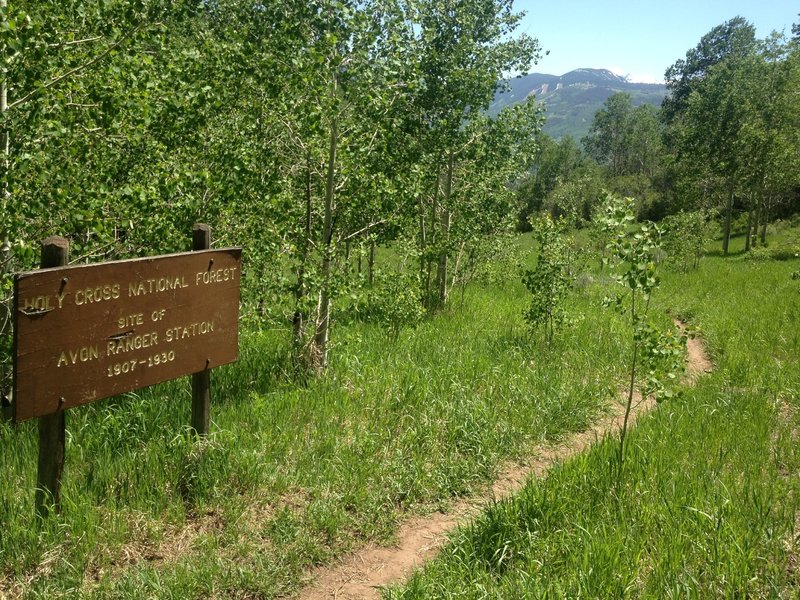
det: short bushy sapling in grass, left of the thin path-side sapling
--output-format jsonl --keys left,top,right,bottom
{"left": 522, "top": 216, "right": 574, "bottom": 343}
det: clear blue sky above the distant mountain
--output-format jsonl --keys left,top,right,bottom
{"left": 514, "top": 0, "right": 800, "bottom": 82}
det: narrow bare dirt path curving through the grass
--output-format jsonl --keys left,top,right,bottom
{"left": 298, "top": 321, "right": 713, "bottom": 600}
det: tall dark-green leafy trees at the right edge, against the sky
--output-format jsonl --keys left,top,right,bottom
{"left": 664, "top": 17, "right": 800, "bottom": 248}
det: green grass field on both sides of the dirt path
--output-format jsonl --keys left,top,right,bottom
{"left": 0, "top": 229, "right": 800, "bottom": 598}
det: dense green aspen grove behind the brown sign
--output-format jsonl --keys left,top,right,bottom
{"left": 0, "top": 0, "right": 541, "bottom": 389}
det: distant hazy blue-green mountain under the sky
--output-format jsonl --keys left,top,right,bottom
{"left": 489, "top": 69, "right": 667, "bottom": 141}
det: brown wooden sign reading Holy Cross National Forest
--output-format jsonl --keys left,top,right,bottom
{"left": 14, "top": 248, "right": 241, "bottom": 422}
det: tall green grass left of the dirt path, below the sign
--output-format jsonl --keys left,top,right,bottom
{"left": 0, "top": 247, "right": 636, "bottom": 598}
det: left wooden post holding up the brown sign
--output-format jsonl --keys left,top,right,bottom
{"left": 35, "top": 236, "right": 69, "bottom": 518}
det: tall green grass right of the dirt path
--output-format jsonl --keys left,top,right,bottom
{"left": 386, "top": 252, "right": 800, "bottom": 599}
